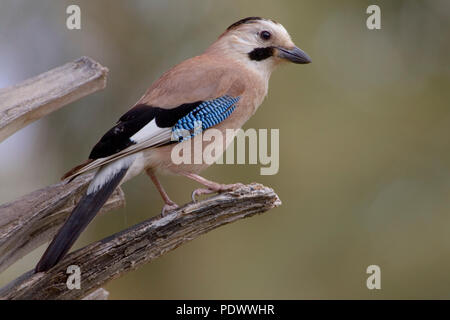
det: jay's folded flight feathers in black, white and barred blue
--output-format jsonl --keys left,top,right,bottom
{"left": 63, "top": 95, "right": 240, "bottom": 180}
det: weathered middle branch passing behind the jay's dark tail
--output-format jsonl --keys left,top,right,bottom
{"left": 0, "top": 174, "right": 125, "bottom": 272}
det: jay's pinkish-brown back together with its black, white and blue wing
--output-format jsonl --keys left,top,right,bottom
{"left": 63, "top": 55, "right": 245, "bottom": 179}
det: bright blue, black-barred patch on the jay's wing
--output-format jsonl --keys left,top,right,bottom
{"left": 172, "top": 95, "right": 240, "bottom": 142}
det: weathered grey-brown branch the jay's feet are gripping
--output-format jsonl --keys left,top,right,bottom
{"left": 0, "top": 184, "right": 281, "bottom": 299}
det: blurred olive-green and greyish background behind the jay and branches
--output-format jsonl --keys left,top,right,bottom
{"left": 0, "top": 0, "right": 450, "bottom": 299}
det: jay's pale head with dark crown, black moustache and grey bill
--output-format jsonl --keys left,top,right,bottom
{"left": 212, "top": 17, "right": 311, "bottom": 75}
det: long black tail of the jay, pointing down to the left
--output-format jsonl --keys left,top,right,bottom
{"left": 35, "top": 168, "right": 128, "bottom": 272}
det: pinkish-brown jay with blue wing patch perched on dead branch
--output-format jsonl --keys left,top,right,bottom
{"left": 35, "top": 17, "right": 311, "bottom": 273}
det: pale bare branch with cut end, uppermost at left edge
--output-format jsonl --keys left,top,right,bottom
{"left": 0, "top": 57, "right": 108, "bottom": 142}
